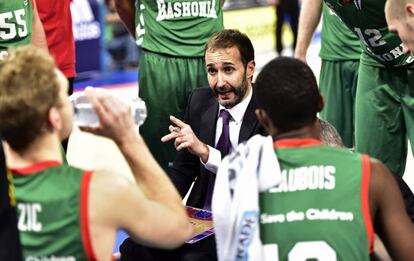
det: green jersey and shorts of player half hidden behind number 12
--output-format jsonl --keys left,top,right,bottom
{"left": 319, "top": 4, "right": 362, "bottom": 147}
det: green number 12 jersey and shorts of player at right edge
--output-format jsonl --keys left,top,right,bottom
{"left": 325, "top": 0, "right": 414, "bottom": 175}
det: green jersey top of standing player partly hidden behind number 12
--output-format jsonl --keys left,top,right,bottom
{"left": 319, "top": 4, "right": 362, "bottom": 61}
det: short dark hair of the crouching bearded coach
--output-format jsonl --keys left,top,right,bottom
{"left": 204, "top": 29, "right": 254, "bottom": 68}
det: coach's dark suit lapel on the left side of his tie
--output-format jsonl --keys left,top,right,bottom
{"left": 200, "top": 96, "right": 218, "bottom": 147}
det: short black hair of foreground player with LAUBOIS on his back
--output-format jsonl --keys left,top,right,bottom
{"left": 255, "top": 57, "right": 320, "bottom": 132}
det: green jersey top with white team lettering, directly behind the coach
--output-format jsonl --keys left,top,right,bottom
{"left": 135, "top": 0, "right": 223, "bottom": 57}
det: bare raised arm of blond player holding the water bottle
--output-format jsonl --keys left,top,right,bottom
{"left": 83, "top": 90, "right": 192, "bottom": 252}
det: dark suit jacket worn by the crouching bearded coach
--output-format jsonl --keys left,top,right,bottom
{"left": 169, "top": 88, "right": 264, "bottom": 208}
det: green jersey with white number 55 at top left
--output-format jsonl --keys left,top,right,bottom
{"left": 0, "top": 0, "right": 33, "bottom": 53}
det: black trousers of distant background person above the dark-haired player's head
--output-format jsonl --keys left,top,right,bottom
{"left": 276, "top": 0, "right": 300, "bottom": 55}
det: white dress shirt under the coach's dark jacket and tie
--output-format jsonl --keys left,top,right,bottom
{"left": 200, "top": 87, "right": 253, "bottom": 174}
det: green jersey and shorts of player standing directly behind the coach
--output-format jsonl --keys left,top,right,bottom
{"left": 135, "top": 0, "right": 223, "bottom": 170}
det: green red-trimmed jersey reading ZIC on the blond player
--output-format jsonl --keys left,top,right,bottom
{"left": 12, "top": 161, "right": 94, "bottom": 260}
